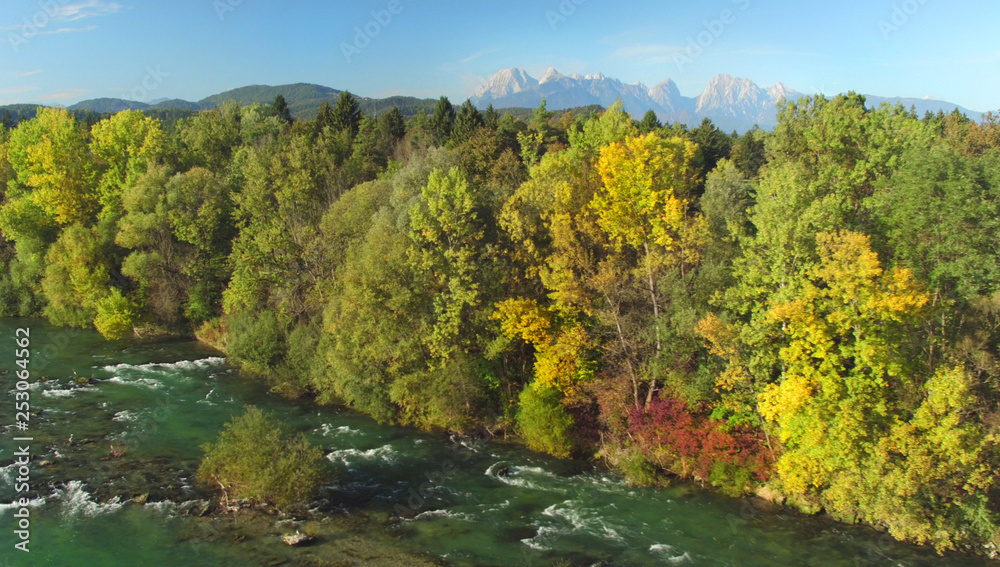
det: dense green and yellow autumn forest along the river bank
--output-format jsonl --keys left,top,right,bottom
{"left": 0, "top": 93, "right": 1000, "bottom": 551}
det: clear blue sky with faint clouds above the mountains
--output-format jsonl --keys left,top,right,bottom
{"left": 0, "top": 0, "right": 1000, "bottom": 111}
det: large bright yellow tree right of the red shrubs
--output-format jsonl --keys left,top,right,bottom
{"left": 758, "top": 232, "right": 928, "bottom": 493}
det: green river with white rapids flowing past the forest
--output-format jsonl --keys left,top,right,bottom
{"left": 0, "top": 320, "right": 996, "bottom": 567}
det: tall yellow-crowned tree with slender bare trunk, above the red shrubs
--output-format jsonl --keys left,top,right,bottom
{"left": 590, "top": 134, "right": 707, "bottom": 405}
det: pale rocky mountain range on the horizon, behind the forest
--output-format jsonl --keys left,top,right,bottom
{"left": 472, "top": 67, "right": 981, "bottom": 133}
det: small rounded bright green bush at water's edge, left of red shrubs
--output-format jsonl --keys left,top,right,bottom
{"left": 517, "top": 384, "right": 573, "bottom": 457}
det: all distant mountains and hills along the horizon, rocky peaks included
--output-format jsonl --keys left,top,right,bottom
{"left": 0, "top": 68, "right": 981, "bottom": 133}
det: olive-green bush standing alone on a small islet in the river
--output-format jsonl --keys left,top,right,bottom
{"left": 197, "top": 406, "right": 327, "bottom": 508}
